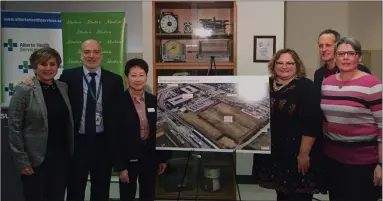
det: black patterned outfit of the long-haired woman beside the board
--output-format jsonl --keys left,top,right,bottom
{"left": 253, "top": 78, "right": 322, "bottom": 192}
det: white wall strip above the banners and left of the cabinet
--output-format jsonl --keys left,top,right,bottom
{"left": 1, "top": 1, "right": 143, "bottom": 53}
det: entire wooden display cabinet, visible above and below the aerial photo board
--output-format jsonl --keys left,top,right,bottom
{"left": 153, "top": 1, "right": 237, "bottom": 200}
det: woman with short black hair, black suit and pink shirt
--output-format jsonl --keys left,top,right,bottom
{"left": 114, "top": 59, "right": 170, "bottom": 201}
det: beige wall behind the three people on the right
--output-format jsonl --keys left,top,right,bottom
{"left": 285, "top": 1, "right": 382, "bottom": 79}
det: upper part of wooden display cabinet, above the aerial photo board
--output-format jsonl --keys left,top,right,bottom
{"left": 153, "top": 1, "right": 237, "bottom": 92}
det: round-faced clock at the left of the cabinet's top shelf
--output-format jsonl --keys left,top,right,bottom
{"left": 157, "top": 12, "right": 178, "bottom": 33}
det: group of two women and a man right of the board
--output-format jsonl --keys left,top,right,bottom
{"left": 253, "top": 29, "right": 382, "bottom": 201}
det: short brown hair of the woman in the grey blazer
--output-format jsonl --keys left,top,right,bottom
{"left": 29, "top": 47, "right": 62, "bottom": 69}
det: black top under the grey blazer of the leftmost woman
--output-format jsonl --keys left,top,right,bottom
{"left": 40, "top": 82, "right": 69, "bottom": 154}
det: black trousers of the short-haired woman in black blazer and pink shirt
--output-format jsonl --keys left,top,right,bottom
{"left": 119, "top": 154, "right": 158, "bottom": 201}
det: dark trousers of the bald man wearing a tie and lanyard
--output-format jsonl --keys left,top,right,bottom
{"left": 67, "top": 133, "right": 112, "bottom": 201}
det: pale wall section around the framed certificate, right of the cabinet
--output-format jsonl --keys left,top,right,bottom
{"left": 236, "top": 0, "right": 285, "bottom": 175}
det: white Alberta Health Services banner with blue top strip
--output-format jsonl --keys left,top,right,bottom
{"left": 1, "top": 11, "right": 63, "bottom": 106}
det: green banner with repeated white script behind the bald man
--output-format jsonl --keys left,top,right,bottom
{"left": 62, "top": 12, "right": 126, "bottom": 76}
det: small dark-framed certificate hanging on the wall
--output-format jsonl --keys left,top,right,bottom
{"left": 253, "top": 36, "right": 276, "bottom": 63}
